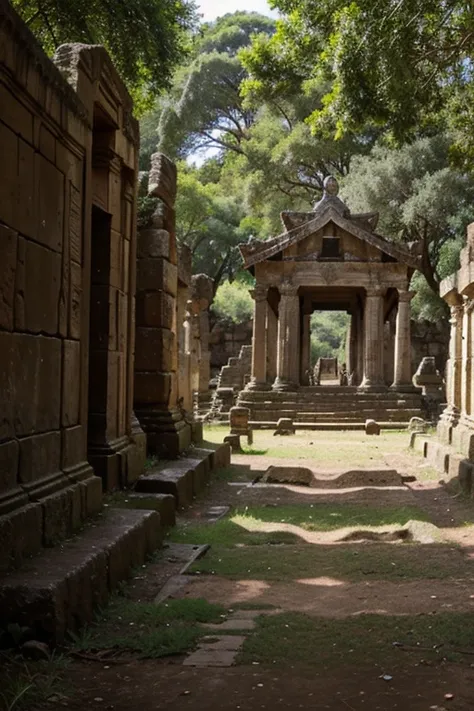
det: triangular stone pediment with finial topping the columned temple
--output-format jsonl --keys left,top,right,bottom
{"left": 239, "top": 179, "right": 420, "bottom": 269}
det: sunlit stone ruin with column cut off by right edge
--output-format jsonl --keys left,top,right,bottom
{"left": 417, "top": 223, "right": 474, "bottom": 492}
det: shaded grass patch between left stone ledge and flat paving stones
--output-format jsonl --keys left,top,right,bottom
{"left": 69, "top": 595, "right": 226, "bottom": 658}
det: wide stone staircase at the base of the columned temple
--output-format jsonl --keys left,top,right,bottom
{"left": 238, "top": 385, "right": 425, "bottom": 430}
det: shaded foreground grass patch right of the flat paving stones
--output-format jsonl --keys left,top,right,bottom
{"left": 238, "top": 612, "right": 474, "bottom": 671}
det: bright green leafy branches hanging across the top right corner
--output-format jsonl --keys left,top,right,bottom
{"left": 241, "top": 0, "right": 474, "bottom": 162}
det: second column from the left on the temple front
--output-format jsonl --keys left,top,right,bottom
{"left": 273, "top": 282, "right": 300, "bottom": 390}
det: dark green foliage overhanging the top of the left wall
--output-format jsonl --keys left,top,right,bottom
{"left": 12, "top": 0, "right": 196, "bottom": 110}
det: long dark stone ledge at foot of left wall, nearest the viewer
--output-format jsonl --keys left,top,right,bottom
{"left": 0, "top": 508, "right": 163, "bottom": 644}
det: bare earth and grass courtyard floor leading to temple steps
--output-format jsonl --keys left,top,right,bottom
{"left": 38, "top": 428, "right": 474, "bottom": 711}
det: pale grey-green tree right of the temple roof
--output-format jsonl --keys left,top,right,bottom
{"left": 342, "top": 134, "right": 474, "bottom": 298}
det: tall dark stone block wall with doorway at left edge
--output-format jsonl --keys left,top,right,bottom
{"left": 0, "top": 0, "right": 143, "bottom": 570}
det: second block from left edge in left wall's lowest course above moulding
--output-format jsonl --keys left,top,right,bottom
{"left": 19, "top": 432, "right": 61, "bottom": 484}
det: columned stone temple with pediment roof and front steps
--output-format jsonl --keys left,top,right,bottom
{"left": 239, "top": 177, "right": 421, "bottom": 426}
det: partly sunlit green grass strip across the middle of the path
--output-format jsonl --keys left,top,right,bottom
{"left": 170, "top": 503, "right": 428, "bottom": 546}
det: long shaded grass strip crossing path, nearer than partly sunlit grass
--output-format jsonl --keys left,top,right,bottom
{"left": 191, "top": 543, "right": 466, "bottom": 582}
